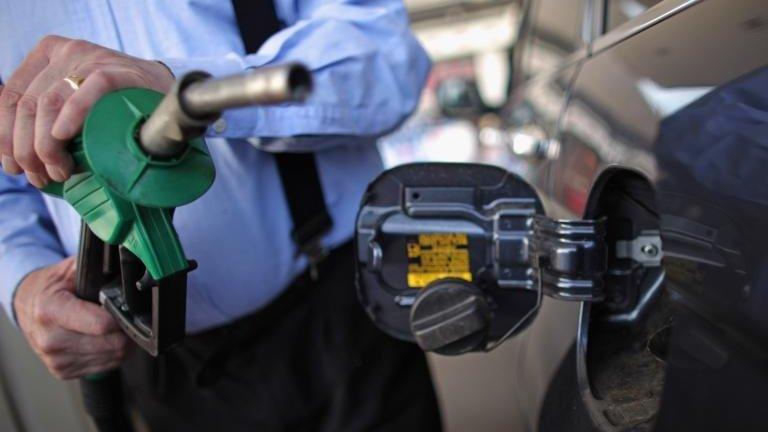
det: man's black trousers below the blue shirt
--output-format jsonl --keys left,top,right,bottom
{"left": 123, "top": 245, "right": 441, "bottom": 432}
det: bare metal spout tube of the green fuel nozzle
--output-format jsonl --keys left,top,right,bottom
{"left": 139, "top": 63, "right": 312, "bottom": 158}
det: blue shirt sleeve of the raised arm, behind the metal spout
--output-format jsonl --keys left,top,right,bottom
{"left": 160, "top": 0, "right": 430, "bottom": 142}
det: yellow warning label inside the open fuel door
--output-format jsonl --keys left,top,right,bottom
{"left": 406, "top": 233, "right": 472, "bottom": 288}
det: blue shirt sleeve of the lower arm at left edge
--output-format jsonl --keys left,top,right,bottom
{"left": 0, "top": 173, "right": 65, "bottom": 322}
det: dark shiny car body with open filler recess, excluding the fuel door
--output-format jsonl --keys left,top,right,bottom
{"left": 498, "top": 0, "right": 768, "bottom": 431}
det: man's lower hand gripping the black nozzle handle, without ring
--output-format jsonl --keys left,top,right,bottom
{"left": 13, "top": 258, "right": 128, "bottom": 379}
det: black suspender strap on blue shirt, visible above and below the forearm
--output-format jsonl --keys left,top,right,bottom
{"left": 232, "top": 0, "right": 333, "bottom": 278}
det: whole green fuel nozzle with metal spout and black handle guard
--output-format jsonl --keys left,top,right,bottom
{"left": 43, "top": 64, "right": 312, "bottom": 355}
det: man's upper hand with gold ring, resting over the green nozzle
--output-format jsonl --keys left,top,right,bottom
{"left": 0, "top": 36, "right": 174, "bottom": 187}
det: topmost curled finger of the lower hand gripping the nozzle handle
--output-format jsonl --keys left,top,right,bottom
{"left": 48, "top": 290, "right": 119, "bottom": 336}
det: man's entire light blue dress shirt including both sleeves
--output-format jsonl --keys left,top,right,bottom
{"left": 0, "top": 0, "right": 429, "bottom": 332}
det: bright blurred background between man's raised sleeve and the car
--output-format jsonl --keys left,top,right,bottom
{"left": 381, "top": 0, "right": 522, "bottom": 172}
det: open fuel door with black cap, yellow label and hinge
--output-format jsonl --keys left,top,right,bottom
{"left": 355, "top": 163, "right": 606, "bottom": 355}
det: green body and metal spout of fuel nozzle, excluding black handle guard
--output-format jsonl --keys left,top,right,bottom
{"left": 43, "top": 64, "right": 312, "bottom": 280}
